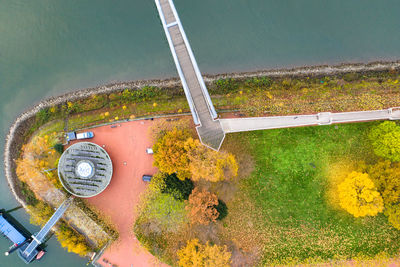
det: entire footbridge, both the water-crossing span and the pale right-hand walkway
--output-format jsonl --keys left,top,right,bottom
{"left": 155, "top": 0, "right": 400, "bottom": 150}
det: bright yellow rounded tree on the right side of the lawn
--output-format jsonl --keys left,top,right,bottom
{"left": 338, "top": 171, "right": 383, "bottom": 217}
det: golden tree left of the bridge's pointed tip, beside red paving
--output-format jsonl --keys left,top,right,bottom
{"left": 153, "top": 128, "right": 190, "bottom": 180}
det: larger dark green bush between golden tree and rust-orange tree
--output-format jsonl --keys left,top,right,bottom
{"left": 161, "top": 173, "right": 194, "bottom": 200}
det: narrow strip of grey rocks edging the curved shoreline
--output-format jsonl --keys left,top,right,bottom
{"left": 4, "top": 61, "right": 400, "bottom": 213}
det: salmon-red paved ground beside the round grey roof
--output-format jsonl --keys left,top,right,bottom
{"left": 72, "top": 120, "right": 166, "bottom": 267}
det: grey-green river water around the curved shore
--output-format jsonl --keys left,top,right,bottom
{"left": 0, "top": 0, "right": 400, "bottom": 267}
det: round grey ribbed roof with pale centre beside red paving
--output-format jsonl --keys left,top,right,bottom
{"left": 58, "top": 142, "right": 113, "bottom": 197}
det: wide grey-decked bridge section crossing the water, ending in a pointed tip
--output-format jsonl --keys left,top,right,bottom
{"left": 155, "top": 0, "right": 225, "bottom": 150}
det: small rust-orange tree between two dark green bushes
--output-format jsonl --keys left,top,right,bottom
{"left": 187, "top": 187, "right": 219, "bottom": 225}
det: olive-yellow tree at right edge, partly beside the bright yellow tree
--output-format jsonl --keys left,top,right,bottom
{"left": 368, "top": 160, "right": 400, "bottom": 205}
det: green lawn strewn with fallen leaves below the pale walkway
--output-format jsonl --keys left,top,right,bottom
{"left": 225, "top": 122, "right": 400, "bottom": 264}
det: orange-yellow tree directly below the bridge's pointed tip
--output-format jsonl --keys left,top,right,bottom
{"left": 186, "top": 138, "right": 239, "bottom": 182}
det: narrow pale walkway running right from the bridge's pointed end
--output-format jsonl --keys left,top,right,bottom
{"left": 220, "top": 108, "right": 400, "bottom": 133}
